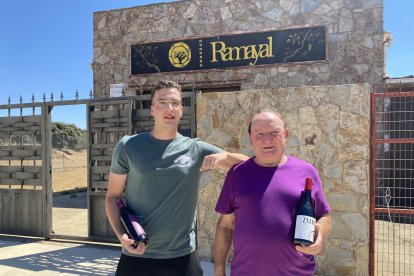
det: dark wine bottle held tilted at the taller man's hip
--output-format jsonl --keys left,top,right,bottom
{"left": 116, "top": 198, "right": 149, "bottom": 247}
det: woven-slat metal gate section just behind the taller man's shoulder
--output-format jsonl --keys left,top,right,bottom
{"left": 87, "top": 99, "right": 134, "bottom": 241}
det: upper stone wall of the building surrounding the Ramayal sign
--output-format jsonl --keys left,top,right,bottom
{"left": 92, "top": 0, "right": 384, "bottom": 98}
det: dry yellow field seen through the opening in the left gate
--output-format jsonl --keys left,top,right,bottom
{"left": 52, "top": 149, "right": 87, "bottom": 192}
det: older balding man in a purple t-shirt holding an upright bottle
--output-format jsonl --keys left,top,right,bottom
{"left": 214, "top": 112, "right": 331, "bottom": 276}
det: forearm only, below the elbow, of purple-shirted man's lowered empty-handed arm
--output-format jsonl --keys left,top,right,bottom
{"left": 214, "top": 225, "right": 233, "bottom": 276}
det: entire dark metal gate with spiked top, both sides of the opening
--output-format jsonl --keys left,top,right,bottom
{"left": 0, "top": 92, "right": 195, "bottom": 241}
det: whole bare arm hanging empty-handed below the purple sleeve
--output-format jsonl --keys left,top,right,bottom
{"left": 214, "top": 214, "right": 235, "bottom": 276}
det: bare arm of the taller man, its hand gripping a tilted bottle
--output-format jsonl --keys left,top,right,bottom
{"left": 105, "top": 173, "right": 145, "bottom": 254}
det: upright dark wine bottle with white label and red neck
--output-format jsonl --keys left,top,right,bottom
{"left": 293, "top": 177, "right": 316, "bottom": 245}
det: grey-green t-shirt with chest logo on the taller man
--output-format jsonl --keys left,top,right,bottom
{"left": 111, "top": 132, "right": 223, "bottom": 259}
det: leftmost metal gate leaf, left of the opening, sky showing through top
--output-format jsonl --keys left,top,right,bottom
{"left": 0, "top": 101, "right": 52, "bottom": 238}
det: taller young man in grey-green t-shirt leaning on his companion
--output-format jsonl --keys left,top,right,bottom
{"left": 105, "top": 81, "right": 247, "bottom": 276}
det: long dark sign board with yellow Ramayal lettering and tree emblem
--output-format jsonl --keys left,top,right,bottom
{"left": 131, "top": 26, "right": 326, "bottom": 75}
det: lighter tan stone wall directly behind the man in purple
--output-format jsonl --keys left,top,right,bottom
{"left": 197, "top": 84, "right": 371, "bottom": 275}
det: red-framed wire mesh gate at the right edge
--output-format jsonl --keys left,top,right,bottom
{"left": 370, "top": 91, "right": 414, "bottom": 275}
